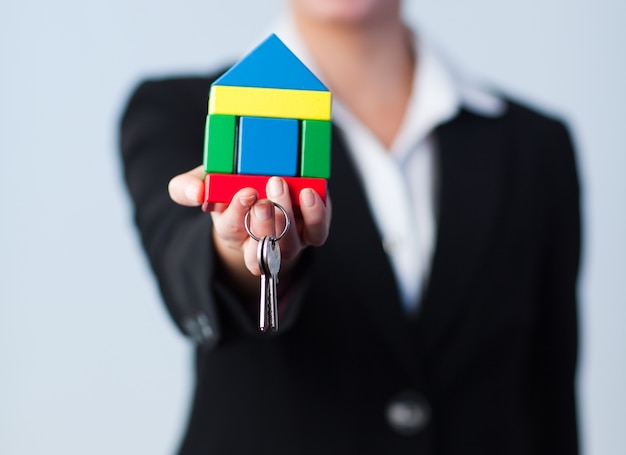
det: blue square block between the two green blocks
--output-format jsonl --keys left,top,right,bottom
{"left": 237, "top": 117, "right": 299, "bottom": 176}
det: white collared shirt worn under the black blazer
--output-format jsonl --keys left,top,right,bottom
{"left": 274, "top": 16, "right": 505, "bottom": 312}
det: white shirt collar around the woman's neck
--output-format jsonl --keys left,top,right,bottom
{"left": 274, "top": 17, "right": 506, "bottom": 159}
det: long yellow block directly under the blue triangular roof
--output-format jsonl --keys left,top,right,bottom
{"left": 209, "top": 85, "right": 331, "bottom": 120}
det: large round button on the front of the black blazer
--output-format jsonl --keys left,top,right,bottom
{"left": 385, "top": 391, "right": 430, "bottom": 436}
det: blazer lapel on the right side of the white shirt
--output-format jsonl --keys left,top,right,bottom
{"left": 417, "top": 111, "right": 510, "bottom": 349}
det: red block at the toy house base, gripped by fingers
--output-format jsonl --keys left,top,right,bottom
{"left": 203, "top": 174, "right": 326, "bottom": 210}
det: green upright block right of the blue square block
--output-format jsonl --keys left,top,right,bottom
{"left": 300, "top": 120, "right": 331, "bottom": 179}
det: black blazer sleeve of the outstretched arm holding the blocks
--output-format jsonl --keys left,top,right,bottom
{"left": 119, "top": 78, "right": 309, "bottom": 348}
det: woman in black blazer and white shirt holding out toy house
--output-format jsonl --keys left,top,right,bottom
{"left": 122, "top": 0, "right": 580, "bottom": 455}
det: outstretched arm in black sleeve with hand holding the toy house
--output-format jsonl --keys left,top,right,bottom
{"left": 120, "top": 78, "right": 331, "bottom": 347}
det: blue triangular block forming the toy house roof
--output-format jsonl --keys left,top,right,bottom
{"left": 213, "top": 34, "right": 328, "bottom": 91}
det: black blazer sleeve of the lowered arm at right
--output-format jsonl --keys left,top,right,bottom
{"left": 532, "top": 116, "right": 581, "bottom": 455}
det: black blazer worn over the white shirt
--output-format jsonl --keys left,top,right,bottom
{"left": 121, "top": 73, "right": 580, "bottom": 455}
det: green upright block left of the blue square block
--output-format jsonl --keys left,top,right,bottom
{"left": 204, "top": 114, "right": 237, "bottom": 174}
